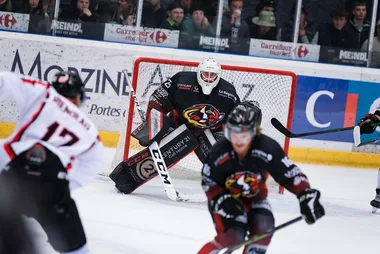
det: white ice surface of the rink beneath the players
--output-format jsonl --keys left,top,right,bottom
{"left": 30, "top": 148, "right": 380, "bottom": 254}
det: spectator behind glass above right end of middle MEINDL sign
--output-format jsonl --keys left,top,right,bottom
{"left": 218, "top": 0, "right": 250, "bottom": 43}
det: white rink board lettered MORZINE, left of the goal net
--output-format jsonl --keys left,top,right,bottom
{"left": 0, "top": 39, "right": 133, "bottom": 132}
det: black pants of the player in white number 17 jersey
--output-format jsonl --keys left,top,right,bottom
{"left": 0, "top": 148, "right": 86, "bottom": 252}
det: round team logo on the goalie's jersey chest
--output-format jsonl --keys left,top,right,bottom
{"left": 183, "top": 104, "right": 225, "bottom": 128}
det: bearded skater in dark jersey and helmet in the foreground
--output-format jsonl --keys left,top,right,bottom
{"left": 199, "top": 104, "right": 325, "bottom": 254}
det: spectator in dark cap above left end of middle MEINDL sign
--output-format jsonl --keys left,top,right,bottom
{"left": 181, "top": 4, "right": 215, "bottom": 48}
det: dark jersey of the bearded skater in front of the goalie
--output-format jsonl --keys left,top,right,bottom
{"left": 202, "top": 134, "right": 310, "bottom": 201}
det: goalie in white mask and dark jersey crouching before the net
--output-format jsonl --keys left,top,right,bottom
{"left": 110, "top": 58, "right": 240, "bottom": 193}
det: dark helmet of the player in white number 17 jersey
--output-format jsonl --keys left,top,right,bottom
{"left": 51, "top": 71, "right": 85, "bottom": 103}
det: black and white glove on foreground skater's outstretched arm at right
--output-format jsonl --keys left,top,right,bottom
{"left": 298, "top": 189, "right": 325, "bottom": 224}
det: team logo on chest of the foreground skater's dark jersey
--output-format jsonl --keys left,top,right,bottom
{"left": 225, "top": 171, "right": 261, "bottom": 198}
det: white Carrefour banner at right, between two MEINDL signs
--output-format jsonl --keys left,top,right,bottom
{"left": 249, "top": 39, "right": 320, "bottom": 62}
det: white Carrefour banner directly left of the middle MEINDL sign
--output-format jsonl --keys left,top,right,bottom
{"left": 104, "top": 24, "right": 179, "bottom": 48}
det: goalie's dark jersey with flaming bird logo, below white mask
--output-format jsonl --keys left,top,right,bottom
{"left": 148, "top": 72, "right": 240, "bottom": 136}
